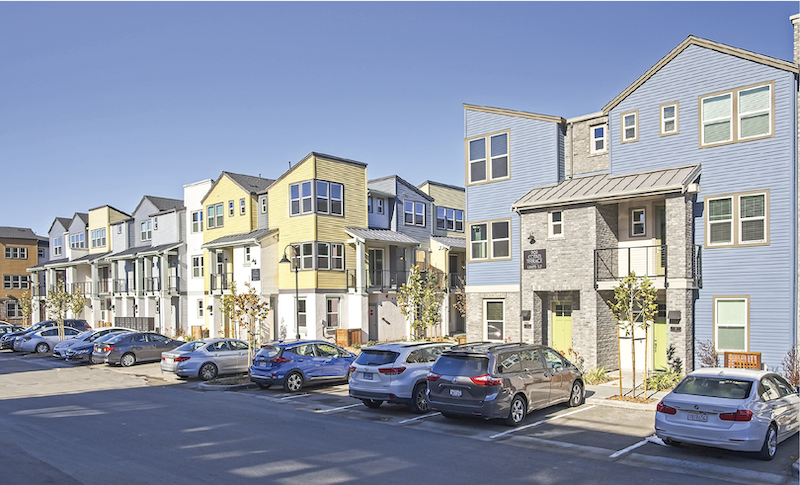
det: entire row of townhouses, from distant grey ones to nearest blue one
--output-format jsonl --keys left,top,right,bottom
{"left": 6, "top": 16, "right": 800, "bottom": 370}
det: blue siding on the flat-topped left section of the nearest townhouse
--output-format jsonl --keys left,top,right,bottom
{"left": 465, "top": 110, "right": 560, "bottom": 286}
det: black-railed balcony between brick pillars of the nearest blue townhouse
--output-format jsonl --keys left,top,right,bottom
{"left": 594, "top": 245, "right": 702, "bottom": 290}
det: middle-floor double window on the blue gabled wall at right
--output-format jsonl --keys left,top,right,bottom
{"left": 706, "top": 192, "right": 769, "bottom": 246}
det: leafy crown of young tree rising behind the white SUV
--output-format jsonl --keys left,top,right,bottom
{"left": 397, "top": 266, "right": 444, "bottom": 339}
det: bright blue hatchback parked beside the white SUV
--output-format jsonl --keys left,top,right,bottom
{"left": 250, "top": 340, "right": 356, "bottom": 392}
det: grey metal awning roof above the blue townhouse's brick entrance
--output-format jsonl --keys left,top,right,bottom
{"left": 511, "top": 165, "right": 700, "bottom": 211}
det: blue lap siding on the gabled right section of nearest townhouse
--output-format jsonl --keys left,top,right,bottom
{"left": 609, "top": 46, "right": 797, "bottom": 367}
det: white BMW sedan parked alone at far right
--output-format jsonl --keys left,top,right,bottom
{"left": 655, "top": 367, "right": 800, "bottom": 460}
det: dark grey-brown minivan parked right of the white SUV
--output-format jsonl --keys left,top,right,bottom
{"left": 428, "top": 342, "right": 584, "bottom": 426}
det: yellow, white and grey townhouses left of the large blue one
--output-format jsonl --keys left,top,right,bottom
{"left": 21, "top": 152, "right": 466, "bottom": 342}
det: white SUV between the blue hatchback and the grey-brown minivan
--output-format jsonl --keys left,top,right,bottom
{"left": 350, "top": 342, "right": 453, "bottom": 413}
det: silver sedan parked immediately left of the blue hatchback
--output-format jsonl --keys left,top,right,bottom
{"left": 161, "top": 339, "right": 250, "bottom": 381}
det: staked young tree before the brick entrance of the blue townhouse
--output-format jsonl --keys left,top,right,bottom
{"left": 608, "top": 271, "right": 658, "bottom": 396}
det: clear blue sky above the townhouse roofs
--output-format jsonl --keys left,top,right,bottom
{"left": 0, "top": 1, "right": 798, "bottom": 236}
